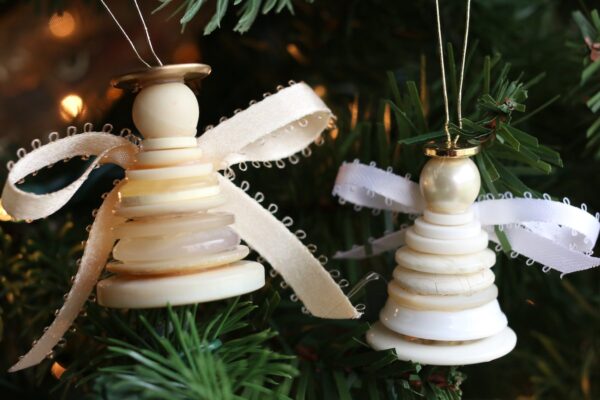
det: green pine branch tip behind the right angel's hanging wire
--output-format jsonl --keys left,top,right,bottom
{"left": 388, "top": 50, "right": 562, "bottom": 199}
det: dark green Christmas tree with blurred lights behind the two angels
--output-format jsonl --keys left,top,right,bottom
{"left": 0, "top": 0, "right": 600, "bottom": 399}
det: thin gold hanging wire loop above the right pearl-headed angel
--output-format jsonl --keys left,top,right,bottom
{"left": 435, "top": 0, "right": 471, "bottom": 147}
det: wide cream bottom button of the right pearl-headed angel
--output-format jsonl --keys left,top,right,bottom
{"left": 367, "top": 322, "right": 517, "bottom": 365}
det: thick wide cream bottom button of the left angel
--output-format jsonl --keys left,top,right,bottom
{"left": 97, "top": 261, "right": 265, "bottom": 308}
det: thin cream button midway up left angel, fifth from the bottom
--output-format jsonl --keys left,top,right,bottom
{"left": 115, "top": 194, "right": 227, "bottom": 218}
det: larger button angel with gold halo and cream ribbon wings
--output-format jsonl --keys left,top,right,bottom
{"left": 2, "top": 64, "right": 359, "bottom": 371}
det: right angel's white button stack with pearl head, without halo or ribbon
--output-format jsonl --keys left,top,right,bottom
{"left": 367, "top": 157, "right": 516, "bottom": 365}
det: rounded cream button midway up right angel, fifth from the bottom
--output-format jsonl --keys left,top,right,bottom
{"left": 396, "top": 246, "right": 496, "bottom": 274}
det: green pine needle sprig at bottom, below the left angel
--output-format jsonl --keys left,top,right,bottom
{"left": 85, "top": 300, "right": 298, "bottom": 400}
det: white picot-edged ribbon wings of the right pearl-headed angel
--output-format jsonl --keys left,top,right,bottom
{"left": 333, "top": 161, "right": 600, "bottom": 276}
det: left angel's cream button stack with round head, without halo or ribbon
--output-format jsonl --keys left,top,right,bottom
{"left": 97, "top": 81, "right": 265, "bottom": 308}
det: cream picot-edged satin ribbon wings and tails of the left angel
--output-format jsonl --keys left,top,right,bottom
{"left": 2, "top": 83, "right": 361, "bottom": 372}
